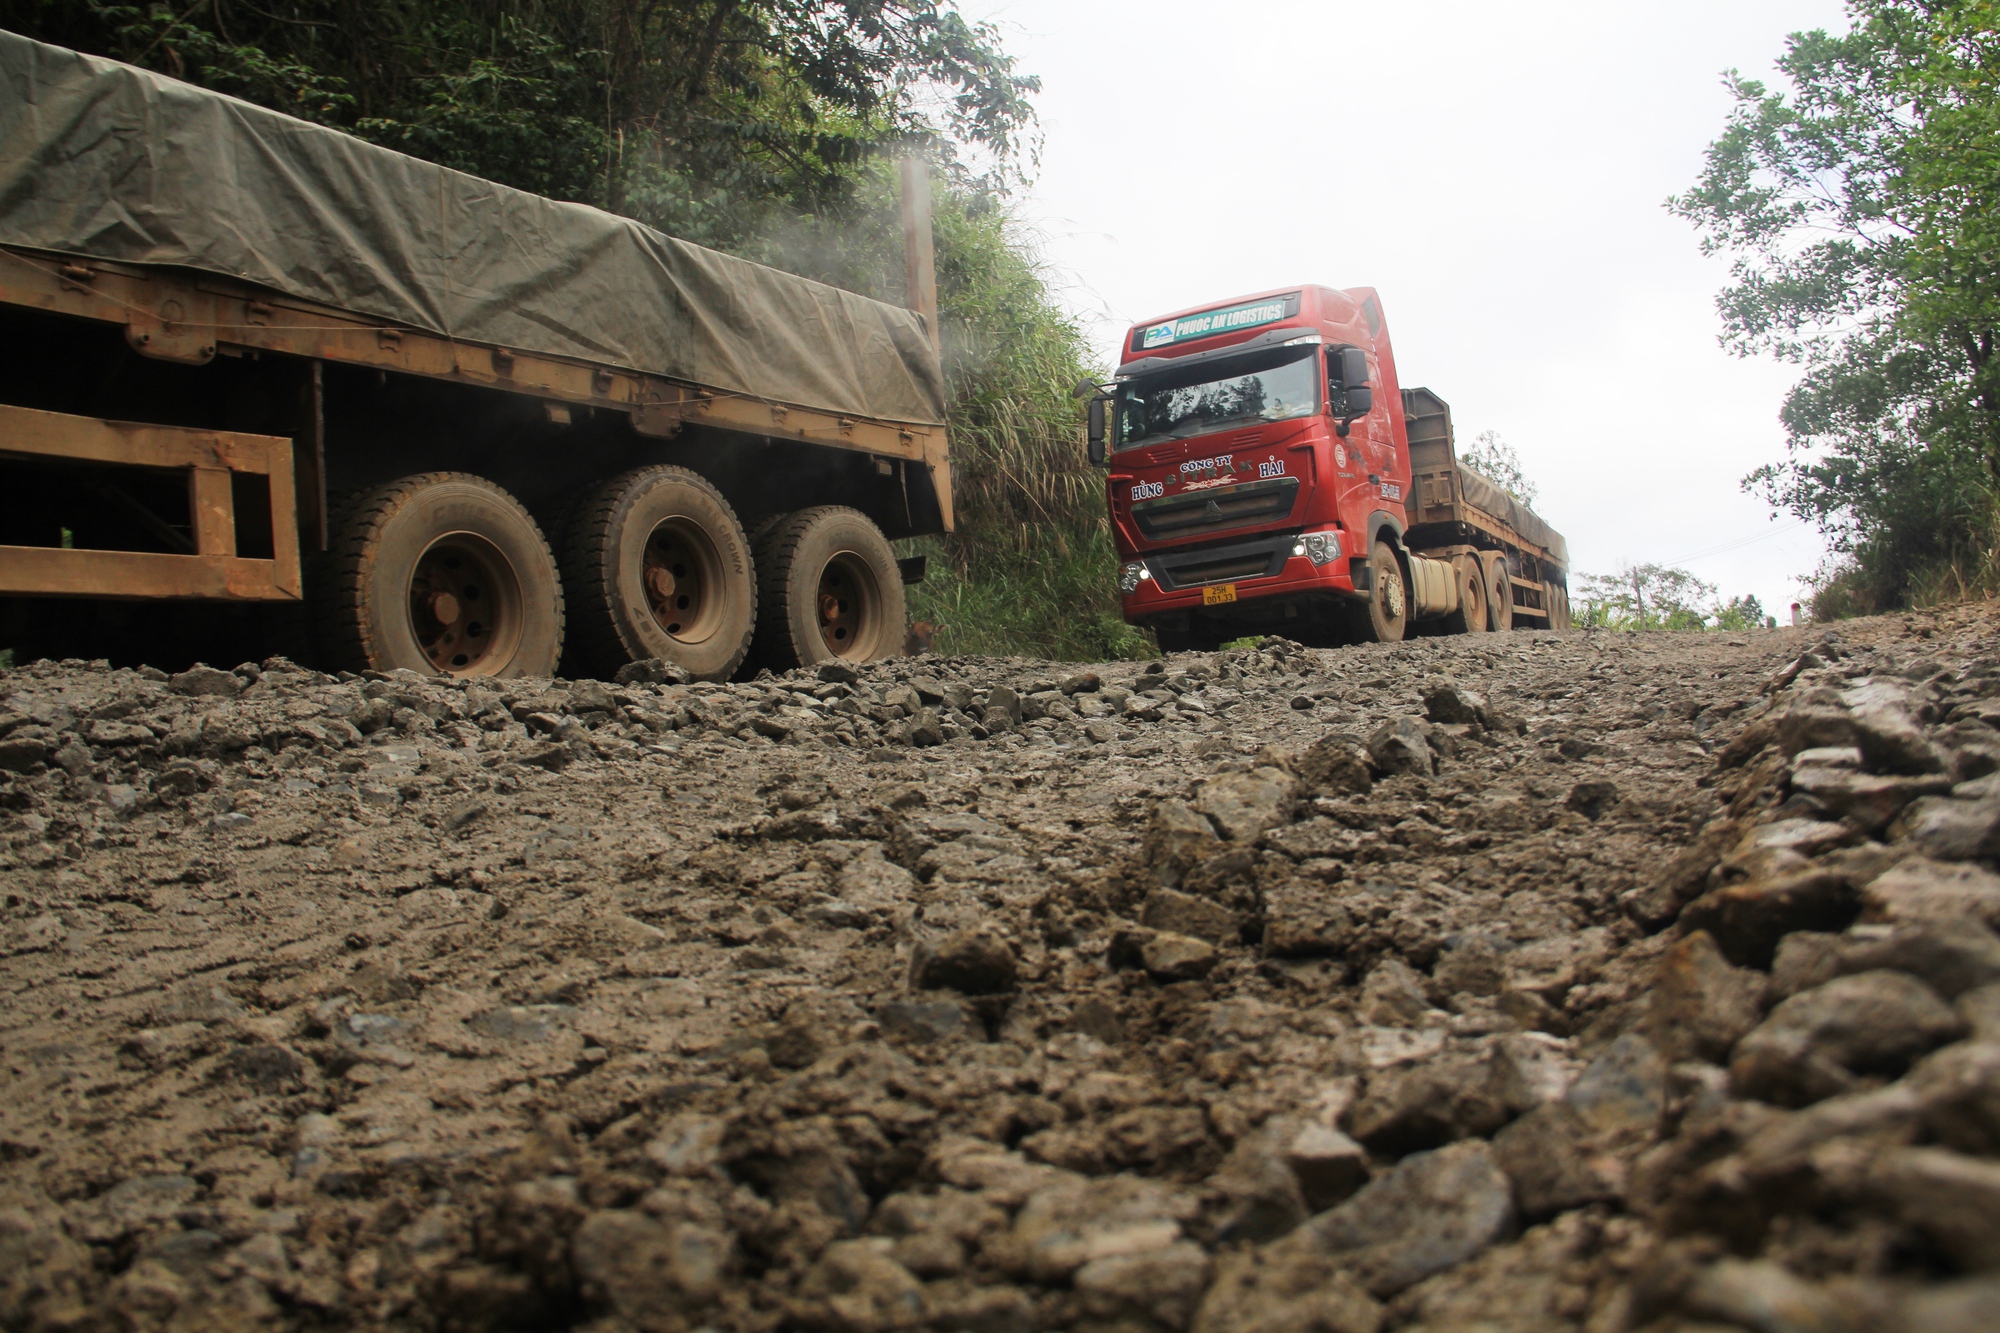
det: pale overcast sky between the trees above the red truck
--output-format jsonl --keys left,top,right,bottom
{"left": 962, "top": 0, "right": 1846, "bottom": 620}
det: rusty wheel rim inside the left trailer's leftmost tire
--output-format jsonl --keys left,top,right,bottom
{"left": 410, "top": 532, "right": 522, "bottom": 677}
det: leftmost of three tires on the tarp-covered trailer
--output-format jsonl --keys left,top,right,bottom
{"left": 312, "top": 472, "right": 562, "bottom": 677}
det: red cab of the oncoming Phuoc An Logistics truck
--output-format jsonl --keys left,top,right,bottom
{"left": 1104, "top": 286, "right": 1410, "bottom": 624}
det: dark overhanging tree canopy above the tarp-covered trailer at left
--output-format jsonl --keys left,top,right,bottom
{"left": 11, "top": 0, "right": 1040, "bottom": 248}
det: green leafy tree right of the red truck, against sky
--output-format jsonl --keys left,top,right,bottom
{"left": 1670, "top": 0, "right": 2000, "bottom": 606}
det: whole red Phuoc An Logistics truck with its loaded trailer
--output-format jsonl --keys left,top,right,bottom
{"left": 1078, "top": 286, "right": 1570, "bottom": 652}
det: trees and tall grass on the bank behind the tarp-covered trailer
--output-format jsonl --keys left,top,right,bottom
{"left": 0, "top": 0, "right": 1154, "bottom": 658}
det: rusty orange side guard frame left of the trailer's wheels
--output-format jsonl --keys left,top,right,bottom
{"left": 0, "top": 404, "right": 302, "bottom": 602}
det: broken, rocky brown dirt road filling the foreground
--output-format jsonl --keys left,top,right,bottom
{"left": 0, "top": 608, "right": 2000, "bottom": 1333}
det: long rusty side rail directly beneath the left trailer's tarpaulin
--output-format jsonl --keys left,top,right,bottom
{"left": 0, "top": 246, "right": 954, "bottom": 532}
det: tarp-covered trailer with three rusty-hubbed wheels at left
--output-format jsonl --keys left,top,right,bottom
{"left": 0, "top": 32, "right": 952, "bottom": 679}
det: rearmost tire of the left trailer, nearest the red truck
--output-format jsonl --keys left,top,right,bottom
{"left": 756, "top": 504, "right": 906, "bottom": 671}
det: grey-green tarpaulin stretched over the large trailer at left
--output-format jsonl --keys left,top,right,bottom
{"left": 0, "top": 32, "right": 944, "bottom": 424}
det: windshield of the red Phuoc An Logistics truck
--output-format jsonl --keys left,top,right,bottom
{"left": 1116, "top": 346, "right": 1320, "bottom": 448}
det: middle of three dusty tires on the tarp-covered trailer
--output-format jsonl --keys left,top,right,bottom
{"left": 562, "top": 464, "right": 756, "bottom": 681}
